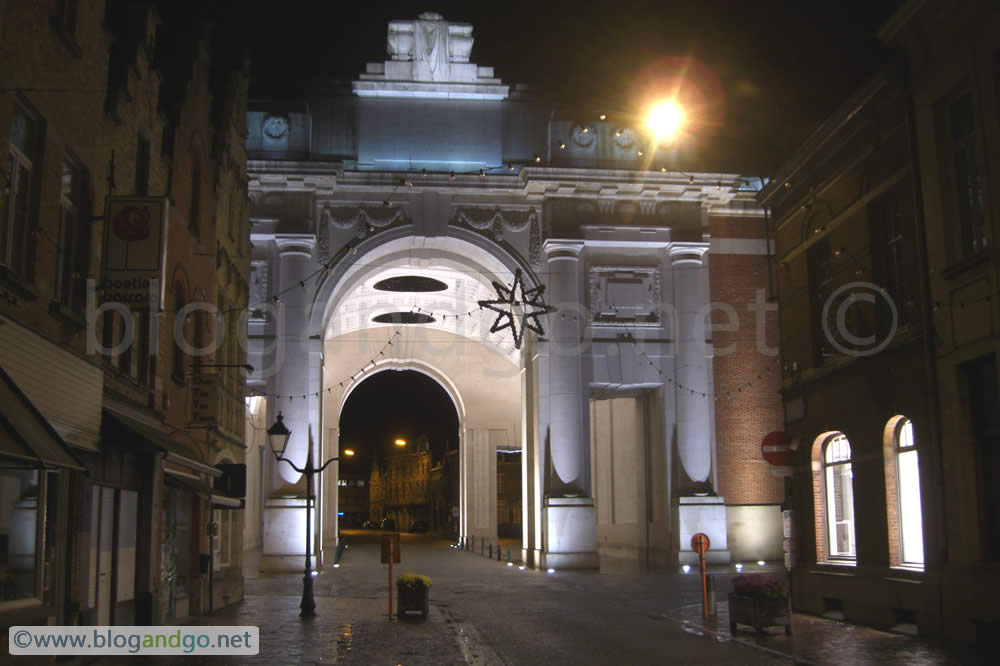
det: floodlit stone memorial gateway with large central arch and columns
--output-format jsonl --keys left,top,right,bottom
{"left": 240, "top": 14, "right": 781, "bottom": 570}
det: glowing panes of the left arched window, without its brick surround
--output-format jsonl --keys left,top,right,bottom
{"left": 823, "top": 434, "right": 855, "bottom": 559}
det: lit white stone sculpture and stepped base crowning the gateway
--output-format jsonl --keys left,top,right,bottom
{"left": 354, "top": 12, "right": 509, "bottom": 100}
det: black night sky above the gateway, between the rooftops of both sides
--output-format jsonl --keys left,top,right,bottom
{"left": 240, "top": 0, "right": 900, "bottom": 170}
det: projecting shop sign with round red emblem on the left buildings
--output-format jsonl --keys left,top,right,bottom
{"left": 97, "top": 197, "right": 169, "bottom": 310}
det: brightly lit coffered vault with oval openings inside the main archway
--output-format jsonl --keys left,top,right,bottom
{"left": 324, "top": 237, "right": 530, "bottom": 364}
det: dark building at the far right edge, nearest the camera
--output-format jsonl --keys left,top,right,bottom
{"left": 879, "top": 0, "right": 1000, "bottom": 646}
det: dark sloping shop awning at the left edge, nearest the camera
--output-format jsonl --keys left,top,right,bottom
{"left": 0, "top": 368, "right": 86, "bottom": 472}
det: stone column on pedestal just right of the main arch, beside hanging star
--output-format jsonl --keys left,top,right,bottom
{"left": 541, "top": 241, "right": 599, "bottom": 569}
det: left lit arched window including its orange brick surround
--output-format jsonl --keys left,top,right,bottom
{"left": 813, "top": 432, "right": 857, "bottom": 561}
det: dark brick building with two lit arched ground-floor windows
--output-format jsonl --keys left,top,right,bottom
{"left": 761, "top": 68, "right": 942, "bottom": 627}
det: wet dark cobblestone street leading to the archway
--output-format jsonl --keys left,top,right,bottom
{"left": 66, "top": 533, "right": 992, "bottom": 666}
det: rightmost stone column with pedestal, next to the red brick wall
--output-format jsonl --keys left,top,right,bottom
{"left": 669, "top": 243, "right": 729, "bottom": 563}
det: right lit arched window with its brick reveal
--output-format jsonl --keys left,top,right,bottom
{"left": 883, "top": 416, "right": 924, "bottom": 566}
